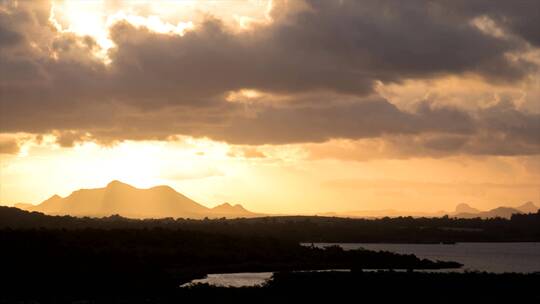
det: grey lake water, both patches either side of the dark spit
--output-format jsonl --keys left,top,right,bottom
{"left": 182, "top": 243, "right": 540, "bottom": 287}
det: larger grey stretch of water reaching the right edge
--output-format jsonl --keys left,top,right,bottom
{"left": 306, "top": 243, "right": 540, "bottom": 273}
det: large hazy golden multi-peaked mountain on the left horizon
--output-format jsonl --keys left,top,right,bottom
{"left": 17, "top": 181, "right": 257, "bottom": 218}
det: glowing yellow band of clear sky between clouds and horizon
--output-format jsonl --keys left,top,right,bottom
{"left": 0, "top": 138, "right": 540, "bottom": 214}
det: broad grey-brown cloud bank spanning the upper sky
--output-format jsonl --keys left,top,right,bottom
{"left": 0, "top": 0, "right": 540, "bottom": 154}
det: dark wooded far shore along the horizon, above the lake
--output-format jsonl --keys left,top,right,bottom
{"left": 0, "top": 207, "right": 540, "bottom": 243}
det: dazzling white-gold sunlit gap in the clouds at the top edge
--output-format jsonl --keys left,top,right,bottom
{"left": 49, "top": 0, "right": 271, "bottom": 63}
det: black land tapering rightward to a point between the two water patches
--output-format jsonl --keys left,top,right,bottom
{"left": 0, "top": 228, "right": 461, "bottom": 294}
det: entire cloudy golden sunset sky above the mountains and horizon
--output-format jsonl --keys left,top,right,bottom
{"left": 0, "top": 0, "right": 540, "bottom": 214}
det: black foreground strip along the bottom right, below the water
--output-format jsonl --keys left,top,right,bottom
{"left": 180, "top": 271, "right": 540, "bottom": 303}
